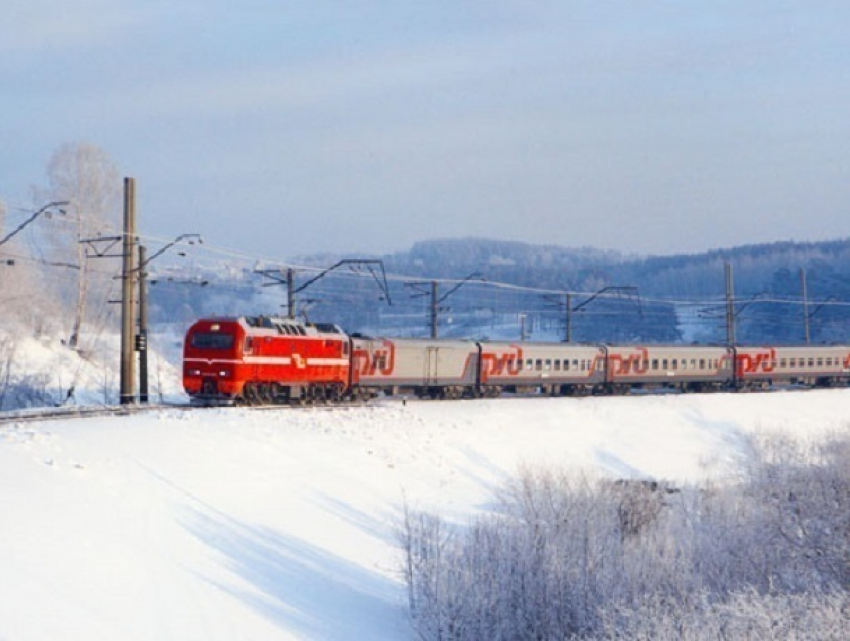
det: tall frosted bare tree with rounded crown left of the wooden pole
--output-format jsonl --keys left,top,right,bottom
{"left": 40, "top": 142, "right": 121, "bottom": 348}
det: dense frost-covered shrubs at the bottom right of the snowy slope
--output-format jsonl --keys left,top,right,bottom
{"left": 401, "top": 438, "right": 850, "bottom": 640}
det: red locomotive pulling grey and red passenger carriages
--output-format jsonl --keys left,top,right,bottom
{"left": 183, "top": 316, "right": 850, "bottom": 405}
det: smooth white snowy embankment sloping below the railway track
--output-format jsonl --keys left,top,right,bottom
{"left": 0, "top": 390, "right": 850, "bottom": 641}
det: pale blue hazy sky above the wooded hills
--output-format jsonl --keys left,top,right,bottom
{"left": 0, "top": 0, "right": 850, "bottom": 258}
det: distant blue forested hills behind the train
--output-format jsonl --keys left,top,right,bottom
{"left": 156, "top": 238, "right": 850, "bottom": 342}
